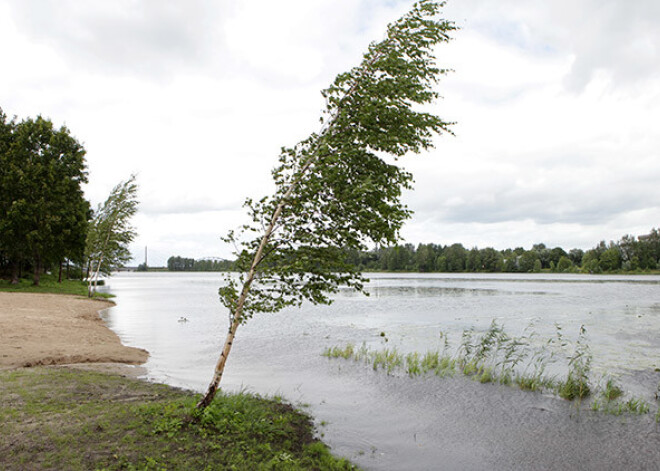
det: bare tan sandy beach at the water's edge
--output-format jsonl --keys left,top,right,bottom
{"left": 0, "top": 292, "right": 149, "bottom": 369}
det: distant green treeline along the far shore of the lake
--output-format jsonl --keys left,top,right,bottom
{"left": 167, "top": 229, "right": 660, "bottom": 273}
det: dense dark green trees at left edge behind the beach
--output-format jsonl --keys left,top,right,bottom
{"left": 0, "top": 109, "right": 91, "bottom": 284}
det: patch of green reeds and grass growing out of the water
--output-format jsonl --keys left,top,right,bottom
{"left": 322, "top": 321, "right": 660, "bottom": 418}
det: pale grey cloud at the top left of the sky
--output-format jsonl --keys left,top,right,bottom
{"left": 5, "top": 0, "right": 229, "bottom": 76}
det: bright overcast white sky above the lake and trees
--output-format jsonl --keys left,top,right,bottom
{"left": 0, "top": 0, "right": 660, "bottom": 265}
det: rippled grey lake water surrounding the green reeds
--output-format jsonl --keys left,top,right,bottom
{"left": 104, "top": 273, "right": 660, "bottom": 469}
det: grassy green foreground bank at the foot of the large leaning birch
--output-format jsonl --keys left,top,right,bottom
{"left": 0, "top": 368, "right": 355, "bottom": 470}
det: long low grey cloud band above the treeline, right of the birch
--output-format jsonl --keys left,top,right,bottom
{"left": 409, "top": 152, "right": 660, "bottom": 227}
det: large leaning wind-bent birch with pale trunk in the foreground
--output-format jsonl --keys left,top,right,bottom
{"left": 198, "top": 0, "right": 455, "bottom": 408}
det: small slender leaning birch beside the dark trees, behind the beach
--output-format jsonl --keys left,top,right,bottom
{"left": 85, "top": 175, "right": 138, "bottom": 296}
